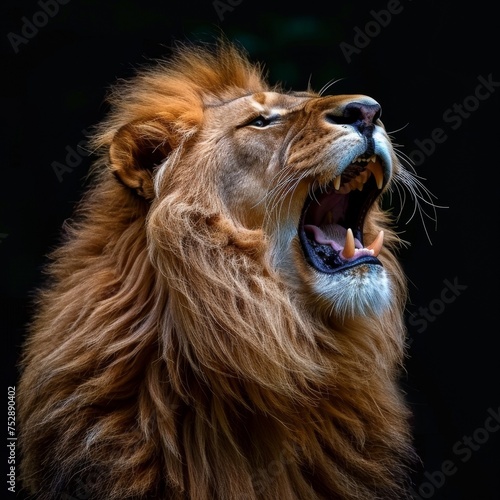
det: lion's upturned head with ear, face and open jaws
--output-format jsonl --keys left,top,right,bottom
{"left": 105, "top": 42, "right": 406, "bottom": 317}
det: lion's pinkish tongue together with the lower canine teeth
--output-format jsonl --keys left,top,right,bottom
{"left": 304, "top": 224, "right": 384, "bottom": 259}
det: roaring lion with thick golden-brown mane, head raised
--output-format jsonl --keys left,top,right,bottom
{"left": 18, "top": 42, "right": 415, "bottom": 500}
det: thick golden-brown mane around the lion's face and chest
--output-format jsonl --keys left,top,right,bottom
{"left": 19, "top": 41, "right": 412, "bottom": 500}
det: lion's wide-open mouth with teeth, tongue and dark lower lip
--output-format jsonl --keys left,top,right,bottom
{"left": 299, "top": 155, "right": 384, "bottom": 274}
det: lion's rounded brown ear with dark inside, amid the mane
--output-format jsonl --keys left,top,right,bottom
{"left": 109, "top": 120, "right": 172, "bottom": 199}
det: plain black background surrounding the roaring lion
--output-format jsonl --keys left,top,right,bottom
{"left": 0, "top": 0, "right": 500, "bottom": 500}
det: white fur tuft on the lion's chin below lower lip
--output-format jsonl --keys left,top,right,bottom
{"left": 314, "top": 264, "right": 391, "bottom": 318}
